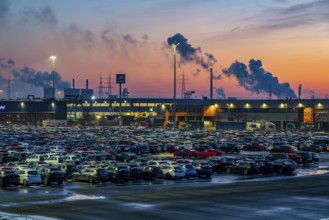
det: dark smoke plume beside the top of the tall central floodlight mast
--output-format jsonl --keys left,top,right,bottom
{"left": 167, "top": 33, "right": 217, "bottom": 73}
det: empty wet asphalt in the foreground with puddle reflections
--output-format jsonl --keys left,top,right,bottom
{"left": 0, "top": 154, "right": 329, "bottom": 219}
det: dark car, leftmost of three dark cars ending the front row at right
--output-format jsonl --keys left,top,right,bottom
{"left": 226, "top": 160, "right": 261, "bottom": 175}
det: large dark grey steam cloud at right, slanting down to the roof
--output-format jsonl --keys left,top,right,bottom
{"left": 222, "top": 59, "right": 297, "bottom": 98}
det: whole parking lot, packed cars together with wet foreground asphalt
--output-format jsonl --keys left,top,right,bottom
{"left": 0, "top": 128, "right": 329, "bottom": 219}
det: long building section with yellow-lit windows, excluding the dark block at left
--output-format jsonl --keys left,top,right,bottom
{"left": 67, "top": 98, "right": 329, "bottom": 131}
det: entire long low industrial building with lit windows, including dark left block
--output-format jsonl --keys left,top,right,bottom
{"left": 0, "top": 87, "right": 329, "bottom": 131}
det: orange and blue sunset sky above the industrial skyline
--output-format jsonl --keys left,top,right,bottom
{"left": 0, "top": 0, "right": 329, "bottom": 98}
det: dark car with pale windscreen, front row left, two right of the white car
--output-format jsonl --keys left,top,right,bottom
{"left": 72, "top": 168, "right": 108, "bottom": 184}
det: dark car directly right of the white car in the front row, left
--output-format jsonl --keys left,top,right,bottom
{"left": 38, "top": 167, "right": 64, "bottom": 185}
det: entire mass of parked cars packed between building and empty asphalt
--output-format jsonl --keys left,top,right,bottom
{"left": 0, "top": 127, "right": 326, "bottom": 186}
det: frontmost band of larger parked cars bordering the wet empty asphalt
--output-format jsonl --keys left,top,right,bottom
{"left": 0, "top": 148, "right": 319, "bottom": 187}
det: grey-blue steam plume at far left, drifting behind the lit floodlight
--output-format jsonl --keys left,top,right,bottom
{"left": 0, "top": 59, "right": 70, "bottom": 89}
